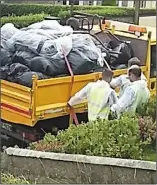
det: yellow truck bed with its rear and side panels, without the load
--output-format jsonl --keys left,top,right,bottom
{"left": 1, "top": 66, "right": 146, "bottom": 127}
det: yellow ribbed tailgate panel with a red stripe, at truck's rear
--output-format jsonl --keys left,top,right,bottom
{"left": 1, "top": 80, "right": 32, "bottom": 125}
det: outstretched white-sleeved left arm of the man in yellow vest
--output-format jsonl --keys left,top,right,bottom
{"left": 68, "top": 83, "right": 92, "bottom": 106}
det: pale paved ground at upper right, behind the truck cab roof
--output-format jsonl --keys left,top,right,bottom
{"left": 139, "top": 16, "right": 156, "bottom": 27}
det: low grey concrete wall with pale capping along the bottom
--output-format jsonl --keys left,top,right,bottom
{"left": 1, "top": 148, "right": 156, "bottom": 184}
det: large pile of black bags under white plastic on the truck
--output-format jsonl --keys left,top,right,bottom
{"left": 1, "top": 20, "right": 134, "bottom": 87}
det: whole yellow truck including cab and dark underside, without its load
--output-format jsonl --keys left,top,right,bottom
{"left": 1, "top": 21, "right": 156, "bottom": 145}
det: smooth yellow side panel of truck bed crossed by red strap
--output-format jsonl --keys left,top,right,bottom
{"left": 36, "top": 73, "right": 99, "bottom": 107}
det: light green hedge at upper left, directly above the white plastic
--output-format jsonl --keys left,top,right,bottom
{"left": 1, "top": 14, "right": 47, "bottom": 28}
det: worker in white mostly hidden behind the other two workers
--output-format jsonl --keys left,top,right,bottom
{"left": 110, "top": 57, "right": 147, "bottom": 97}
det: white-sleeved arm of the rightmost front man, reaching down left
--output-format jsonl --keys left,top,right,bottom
{"left": 111, "top": 87, "right": 136, "bottom": 114}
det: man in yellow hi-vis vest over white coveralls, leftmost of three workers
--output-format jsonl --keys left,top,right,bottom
{"left": 68, "top": 69, "right": 117, "bottom": 121}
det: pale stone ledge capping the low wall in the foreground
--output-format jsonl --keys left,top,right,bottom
{"left": 5, "top": 147, "right": 156, "bottom": 171}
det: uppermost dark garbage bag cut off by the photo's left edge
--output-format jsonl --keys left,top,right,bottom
{"left": 0, "top": 48, "right": 12, "bottom": 66}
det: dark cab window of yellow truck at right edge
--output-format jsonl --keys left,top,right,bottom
{"left": 150, "top": 45, "right": 156, "bottom": 78}
